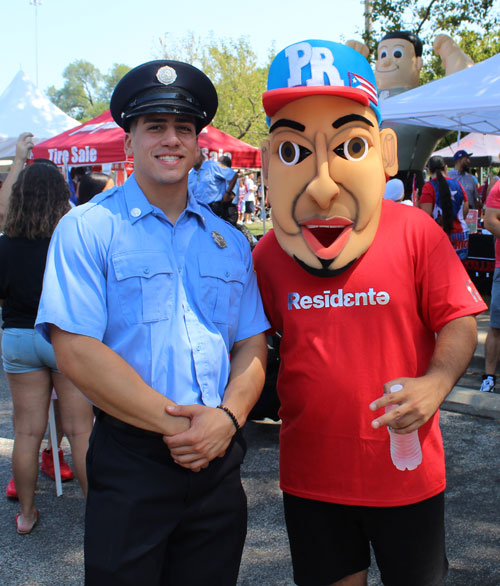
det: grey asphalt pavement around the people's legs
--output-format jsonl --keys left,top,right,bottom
{"left": 0, "top": 308, "right": 500, "bottom": 586}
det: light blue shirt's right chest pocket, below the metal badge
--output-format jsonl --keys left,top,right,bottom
{"left": 198, "top": 253, "right": 246, "bottom": 324}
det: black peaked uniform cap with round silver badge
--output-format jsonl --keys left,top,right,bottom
{"left": 110, "top": 59, "right": 218, "bottom": 133}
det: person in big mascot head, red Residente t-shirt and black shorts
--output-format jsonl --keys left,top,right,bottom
{"left": 254, "top": 40, "right": 486, "bottom": 586}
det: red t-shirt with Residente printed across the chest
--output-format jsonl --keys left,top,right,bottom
{"left": 254, "top": 201, "right": 487, "bottom": 506}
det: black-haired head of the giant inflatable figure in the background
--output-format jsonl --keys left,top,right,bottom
{"left": 375, "top": 31, "right": 423, "bottom": 91}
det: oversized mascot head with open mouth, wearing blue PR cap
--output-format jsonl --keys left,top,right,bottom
{"left": 262, "top": 40, "right": 397, "bottom": 277}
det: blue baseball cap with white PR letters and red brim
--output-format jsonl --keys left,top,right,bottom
{"left": 262, "top": 39, "right": 382, "bottom": 124}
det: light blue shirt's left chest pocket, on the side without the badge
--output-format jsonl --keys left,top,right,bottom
{"left": 111, "top": 250, "right": 175, "bottom": 324}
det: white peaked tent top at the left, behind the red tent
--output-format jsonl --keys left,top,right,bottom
{"left": 0, "top": 71, "right": 80, "bottom": 159}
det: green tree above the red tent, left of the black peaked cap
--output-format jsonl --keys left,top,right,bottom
{"left": 47, "top": 59, "right": 130, "bottom": 122}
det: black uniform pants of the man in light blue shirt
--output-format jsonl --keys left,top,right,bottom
{"left": 85, "top": 414, "right": 247, "bottom": 586}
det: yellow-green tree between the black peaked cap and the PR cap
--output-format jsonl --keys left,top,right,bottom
{"left": 160, "top": 33, "right": 273, "bottom": 146}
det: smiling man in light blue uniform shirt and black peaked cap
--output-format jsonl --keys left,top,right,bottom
{"left": 37, "top": 60, "right": 268, "bottom": 586}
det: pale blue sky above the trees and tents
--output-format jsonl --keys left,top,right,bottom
{"left": 0, "top": 0, "right": 364, "bottom": 93}
